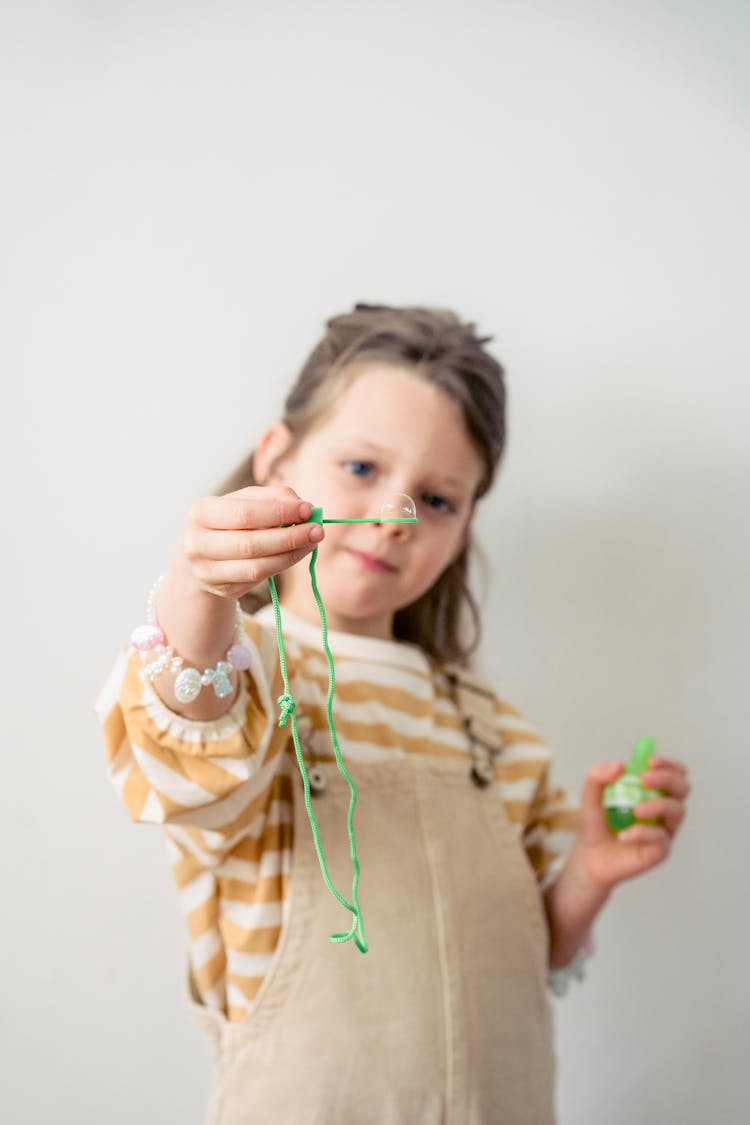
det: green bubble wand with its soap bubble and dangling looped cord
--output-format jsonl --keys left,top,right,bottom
{"left": 269, "top": 494, "right": 417, "bottom": 953}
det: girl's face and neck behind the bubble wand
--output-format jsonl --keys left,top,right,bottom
{"left": 266, "top": 365, "right": 482, "bottom": 638}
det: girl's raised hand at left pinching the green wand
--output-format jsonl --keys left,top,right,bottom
{"left": 181, "top": 485, "right": 324, "bottom": 599}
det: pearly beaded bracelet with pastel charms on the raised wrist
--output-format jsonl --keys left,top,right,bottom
{"left": 130, "top": 578, "right": 252, "bottom": 703}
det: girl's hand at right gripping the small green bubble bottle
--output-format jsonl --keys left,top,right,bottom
{"left": 573, "top": 755, "right": 690, "bottom": 891}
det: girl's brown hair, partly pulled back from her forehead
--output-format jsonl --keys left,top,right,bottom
{"left": 222, "top": 305, "right": 505, "bottom": 664}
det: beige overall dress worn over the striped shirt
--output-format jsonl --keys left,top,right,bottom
{"left": 195, "top": 733, "right": 554, "bottom": 1125}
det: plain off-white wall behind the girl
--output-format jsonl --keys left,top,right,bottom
{"left": 0, "top": 0, "right": 750, "bottom": 1125}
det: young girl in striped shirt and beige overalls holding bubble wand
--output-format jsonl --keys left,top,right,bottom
{"left": 99, "top": 305, "right": 688, "bottom": 1125}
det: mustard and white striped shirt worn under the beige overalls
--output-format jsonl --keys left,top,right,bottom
{"left": 97, "top": 606, "right": 576, "bottom": 1022}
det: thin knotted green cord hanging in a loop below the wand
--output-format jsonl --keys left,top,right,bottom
{"left": 269, "top": 549, "right": 368, "bottom": 953}
